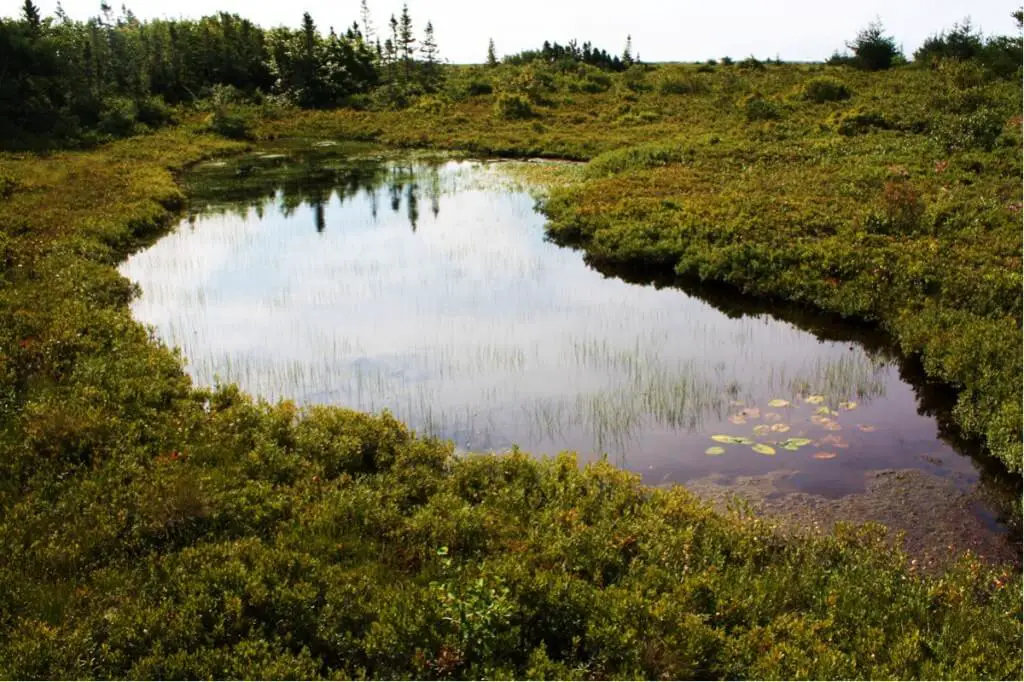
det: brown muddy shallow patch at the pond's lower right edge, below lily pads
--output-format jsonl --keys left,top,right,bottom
{"left": 685, "top": 469, "right": 1021, "bottom": 571}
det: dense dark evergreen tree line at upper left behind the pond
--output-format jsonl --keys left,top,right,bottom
{"left": 0, "top": 0, "right": 441, "bottom": 143}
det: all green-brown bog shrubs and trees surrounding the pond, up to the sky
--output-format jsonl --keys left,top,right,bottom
{"left": 0, "top": 2, "right": 1022, "bottom": 679}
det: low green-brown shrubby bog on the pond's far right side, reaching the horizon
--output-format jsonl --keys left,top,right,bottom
{"left": 261, "top": 62, "right": 1022, "bottom": 472}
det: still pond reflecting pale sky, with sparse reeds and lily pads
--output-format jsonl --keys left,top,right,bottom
{"left": 121, "top": 143, "right": 1004, "bottom": 565}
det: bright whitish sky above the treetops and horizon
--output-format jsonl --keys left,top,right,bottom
{"left": 0, "top": 0, "right": 1017, "bottom": 63}
